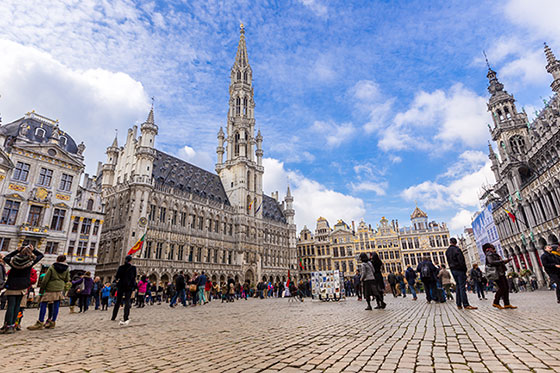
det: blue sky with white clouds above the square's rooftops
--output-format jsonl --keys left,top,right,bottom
{"left": 0, "top": 0, "right": 560, "bottom": 232}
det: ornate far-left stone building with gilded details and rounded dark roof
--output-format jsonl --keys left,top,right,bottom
{"left": 0, "top": 112, "right": 103, "bottom": 273}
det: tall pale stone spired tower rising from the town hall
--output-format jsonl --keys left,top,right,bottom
{"left": 216, "top": 25, "right": 264, "bottom": 216}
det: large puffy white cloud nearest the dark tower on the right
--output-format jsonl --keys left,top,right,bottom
{"left": 378, "top": 83, "right": 489, "bottom": 151}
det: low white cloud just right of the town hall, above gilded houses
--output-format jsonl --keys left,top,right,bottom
{"left": 263, "top": 158, "right": 366, "bottom": 231}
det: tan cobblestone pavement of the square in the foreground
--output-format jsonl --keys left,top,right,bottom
{"left": 0, "top": 291, "right": 560, "bottom": 373}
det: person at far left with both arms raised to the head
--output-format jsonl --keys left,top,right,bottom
{"left": 0, "top": 245, "right": 43, "bottom": 334}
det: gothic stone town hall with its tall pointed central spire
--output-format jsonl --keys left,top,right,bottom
{"left": 97, "top": 27, "right": 296, "bottom": 283}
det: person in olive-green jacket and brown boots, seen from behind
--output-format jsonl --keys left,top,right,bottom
{"left": 27, "top": 255, "right": 70, "bottom": 330}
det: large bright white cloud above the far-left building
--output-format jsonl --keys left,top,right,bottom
{"left": 0, "top": 40, "right": 149, "bottom": 172}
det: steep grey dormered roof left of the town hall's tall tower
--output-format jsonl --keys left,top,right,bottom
{"left": 152, "top": 150, "right": 229, "bottom": 205}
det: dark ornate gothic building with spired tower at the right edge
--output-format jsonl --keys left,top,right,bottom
{"left": 484, "top": 44, "right": 560, "bottom": 283}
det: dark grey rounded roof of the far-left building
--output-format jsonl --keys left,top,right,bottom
{"left": 0, "top": 117, "right": 78, "bottom": 154}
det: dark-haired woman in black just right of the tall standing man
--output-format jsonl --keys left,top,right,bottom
{"left": 482, "top": 243, "right": 517, "bottom": 310}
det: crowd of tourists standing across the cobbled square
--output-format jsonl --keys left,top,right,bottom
{"left": 0, "top": 238, "right": 560, "bottom": 334}
